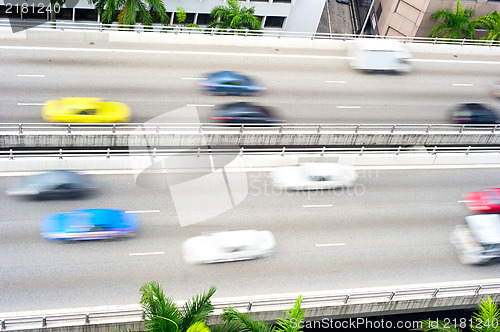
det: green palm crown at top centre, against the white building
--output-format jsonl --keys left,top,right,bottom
{"left": 208, "top": 0, "right": 261, "bottom": 30}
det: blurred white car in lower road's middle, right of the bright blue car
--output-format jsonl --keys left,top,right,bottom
{"left": 182, "top": 230, "right": 276, "bottom": 264}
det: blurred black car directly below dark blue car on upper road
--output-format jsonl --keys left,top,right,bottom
{"left": 211, "top": 102, "right": 283, "bottom": 124}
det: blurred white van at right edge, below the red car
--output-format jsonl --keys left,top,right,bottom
{"left": 450, "top": 214, "right": 500, "bottom": 264}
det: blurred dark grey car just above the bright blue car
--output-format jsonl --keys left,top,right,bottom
{"left": 7, "top": 170, "right": 97, "bottom": 199}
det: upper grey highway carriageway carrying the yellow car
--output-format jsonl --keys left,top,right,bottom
{"left": 0, "top": 40, "right": 500, "bottom": 124}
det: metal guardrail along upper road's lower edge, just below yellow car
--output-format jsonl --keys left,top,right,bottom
{"left": 0, "top": 123, "right": 499, "bottom": 135}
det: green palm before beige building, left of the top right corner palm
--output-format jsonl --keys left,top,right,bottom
{"left": 429, "top": 0, "right": 475, "bottom": 39}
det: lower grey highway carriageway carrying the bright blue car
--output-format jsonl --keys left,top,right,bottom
{"left": 0, "top": 168, "right": 500, "bottom": 312}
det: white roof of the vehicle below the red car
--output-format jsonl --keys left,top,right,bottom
{"left": 465, "top": 214, "right": 500, "bottom": 244}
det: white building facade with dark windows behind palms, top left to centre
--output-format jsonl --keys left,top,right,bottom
{"left": 0, "top": 0, "right": 325, "bottom": 32}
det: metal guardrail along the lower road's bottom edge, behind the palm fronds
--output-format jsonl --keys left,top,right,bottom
{"left": 0, "top": 281, "right": 500, "bottom": 331}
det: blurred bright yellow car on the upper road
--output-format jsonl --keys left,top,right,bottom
{"left": 42, "top": 98, "right": 130, "bottom": 123}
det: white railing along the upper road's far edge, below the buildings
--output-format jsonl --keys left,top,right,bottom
{"left": 0, "top": 20, "right": 500, "bottom": 46}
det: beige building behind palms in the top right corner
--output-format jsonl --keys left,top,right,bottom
{"left": 368, "top": 0, "right": 500, "bottom": 37}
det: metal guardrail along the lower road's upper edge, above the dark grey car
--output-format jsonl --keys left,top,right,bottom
{"left": 0, "top": 146, "right": 500, "bottom": 160}
